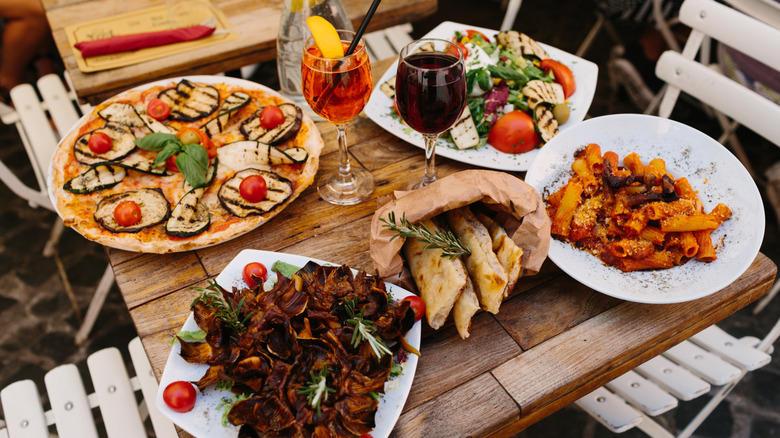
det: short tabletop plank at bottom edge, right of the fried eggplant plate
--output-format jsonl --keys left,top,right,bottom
{"left": 390, "top": 367, "right": 520, "bottom": 437}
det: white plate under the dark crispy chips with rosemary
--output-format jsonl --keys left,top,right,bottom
{"left": 157, "top": 249, "right": 420, "bottom": 438}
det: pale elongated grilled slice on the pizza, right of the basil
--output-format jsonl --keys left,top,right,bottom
{"left": 217, "top": 140, "right": 309, "bottom": 170}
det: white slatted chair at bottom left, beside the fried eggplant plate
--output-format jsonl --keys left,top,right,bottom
{"left": 0, "top": 338, "right": 178, "bottom": 438}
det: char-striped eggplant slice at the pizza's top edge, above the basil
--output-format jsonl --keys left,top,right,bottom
{"left": 158, "top": 79, "right": 219, "bottom": 122}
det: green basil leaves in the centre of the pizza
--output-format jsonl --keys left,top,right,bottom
{"left": 135, "top": 132, "right": 209, "bottom": 188}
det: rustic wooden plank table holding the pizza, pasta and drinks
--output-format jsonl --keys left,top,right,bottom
{"left": 102, "top": 57, "right": 777, "bottom": 436}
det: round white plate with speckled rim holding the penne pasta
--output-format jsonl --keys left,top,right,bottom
{"left": 525, "top": 114, "right": 764, "bottom": 303}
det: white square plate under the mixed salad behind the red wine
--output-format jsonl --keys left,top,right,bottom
{"left": 364, "top": 21, "right": 599, "bottom": 171}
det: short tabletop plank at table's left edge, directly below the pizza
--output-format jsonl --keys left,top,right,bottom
{"left": 113, "top": 252, "right": 206, "bottom": 310}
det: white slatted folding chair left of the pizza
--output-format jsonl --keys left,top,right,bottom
{"left": 0, "top": 74, "right": 114, "bottom": 344}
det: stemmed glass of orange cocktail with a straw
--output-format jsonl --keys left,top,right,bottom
{"left": 301, "top": 30, "right": 374, "bottom": 205}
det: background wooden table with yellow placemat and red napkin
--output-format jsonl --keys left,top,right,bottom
{"left": 42, "top": 0, "right": 437, "bottom": 105}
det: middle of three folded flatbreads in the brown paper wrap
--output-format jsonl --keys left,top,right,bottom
{"left": 446, "top": 207, "right": 509, "bottom": 314}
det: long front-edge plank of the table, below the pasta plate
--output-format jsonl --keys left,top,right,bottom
{"left": 492, "top": 254, "right": 777, "bottom": 430}
